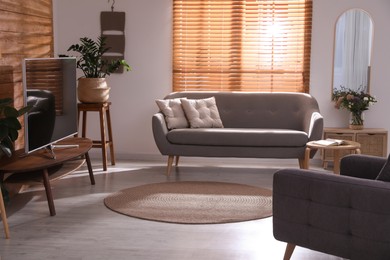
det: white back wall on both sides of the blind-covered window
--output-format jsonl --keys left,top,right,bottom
{"left": 53, "top": 0, "right": 390, "bottom": 158}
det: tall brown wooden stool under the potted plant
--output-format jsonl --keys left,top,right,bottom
{"left": 78, "top": 102, "right": 115, "bottom": 171}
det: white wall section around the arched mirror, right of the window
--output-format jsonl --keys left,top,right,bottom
{"left": 310, "top": 0, "right": 390, "bottom": 132}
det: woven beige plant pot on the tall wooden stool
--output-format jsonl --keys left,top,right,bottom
{"left": 77, "top": 78, "right": 110, "bottom": 103}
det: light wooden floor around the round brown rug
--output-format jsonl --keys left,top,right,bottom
{"left": 0, "top": 159, "right": 348, "bottom": 260}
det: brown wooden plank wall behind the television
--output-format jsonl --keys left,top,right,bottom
{"left": 0, "top": 0, "right": 53, "bottom": 148}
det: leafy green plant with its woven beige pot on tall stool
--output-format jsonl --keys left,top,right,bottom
{"left": 62, "top": 36, "right": 131, "bottom": 103}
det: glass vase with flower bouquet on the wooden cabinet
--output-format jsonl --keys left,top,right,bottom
{"left": 332, "top": 86, "right": 377, "bottom": 130}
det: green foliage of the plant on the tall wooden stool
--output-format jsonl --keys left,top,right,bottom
{"left": 60, "top": 36, "right": 131, "bottom": 78}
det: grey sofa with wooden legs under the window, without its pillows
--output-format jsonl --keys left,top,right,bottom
{"left": 152, "top": 92, "right": 323, "bottom": 175}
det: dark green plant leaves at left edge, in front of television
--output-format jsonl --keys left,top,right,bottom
{"left": 0, "top": 98, "right": 31, "bottom": 157}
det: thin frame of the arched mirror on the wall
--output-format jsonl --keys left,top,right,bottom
{"left": 331, "top": 8, "right": 374, "bottom": 98}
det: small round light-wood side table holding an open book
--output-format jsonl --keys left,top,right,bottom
{"left": 303, "top": 140, "right": 360, "bottom": 174}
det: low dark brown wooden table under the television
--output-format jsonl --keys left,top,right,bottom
{"left": 0, "top": 137, "right": 95, "bottom": 216}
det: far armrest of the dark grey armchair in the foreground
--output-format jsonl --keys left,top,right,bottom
{"left": 340, "top": 154, "right": 386, "bottom": 180}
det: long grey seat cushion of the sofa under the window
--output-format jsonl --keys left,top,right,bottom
{"left": 167, "top": 128, "right": 308, "bottom": 147}
